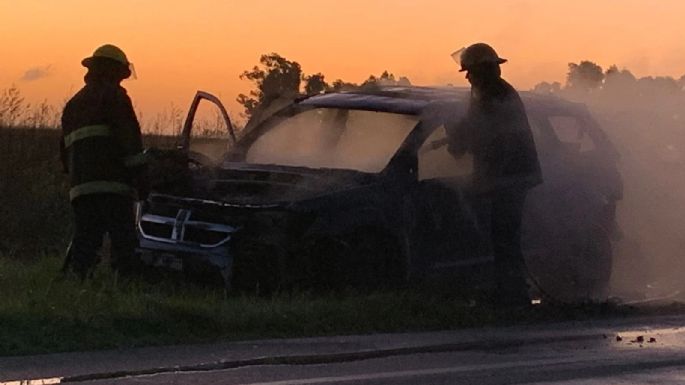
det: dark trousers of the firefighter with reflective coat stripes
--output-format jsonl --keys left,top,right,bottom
{"left": 64, "top": 194, "right": 139, "bottom": 278}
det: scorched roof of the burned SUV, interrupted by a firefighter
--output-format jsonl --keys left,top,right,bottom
{"left": 299, "top": 86, "right": 585, "bottom": 115}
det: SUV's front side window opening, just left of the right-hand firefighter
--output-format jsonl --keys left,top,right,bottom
{"left": 418, "top": 125, "right": 473, "bottom": 180}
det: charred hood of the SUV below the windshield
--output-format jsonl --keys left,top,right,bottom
{"left": 198, "top": 162, "right": 378, "bottom": 205}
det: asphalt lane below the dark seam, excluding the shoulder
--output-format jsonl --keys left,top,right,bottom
{"left": 86, "top": 322, "right": 685, "bottom": 385}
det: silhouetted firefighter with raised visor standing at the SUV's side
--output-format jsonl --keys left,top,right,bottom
{"left": 447, "top": 43, "right": 542, "bottom": 306}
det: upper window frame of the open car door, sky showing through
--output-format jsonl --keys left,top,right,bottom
{"left": 179, "top": 91, "right": 236, "bottom": 165}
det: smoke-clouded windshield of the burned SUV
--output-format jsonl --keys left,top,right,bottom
{"left": 245, "top": 108, "right": 418, "bottom": 173}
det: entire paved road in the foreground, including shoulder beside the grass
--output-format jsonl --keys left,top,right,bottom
{"left": 0, "top": 316, "right": 685, "bottom": 385}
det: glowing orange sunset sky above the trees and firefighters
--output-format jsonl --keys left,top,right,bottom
{"left": 0, "top": 0, "right": 685, "bottom": 124}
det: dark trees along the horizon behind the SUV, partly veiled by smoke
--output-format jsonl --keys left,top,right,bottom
{"left": 237, "top": 53, "right": 685, "bottom": 119}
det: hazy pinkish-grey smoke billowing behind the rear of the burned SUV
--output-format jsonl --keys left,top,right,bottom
{"left": 564, "top": 76, "right": 685, "bottom": 298}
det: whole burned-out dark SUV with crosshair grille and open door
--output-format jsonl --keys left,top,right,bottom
{"left": 138, "top": 87, "right": 622, "bottom": 298}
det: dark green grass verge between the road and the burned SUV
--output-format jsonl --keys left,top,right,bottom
{"left": 0, "top": 252, "right": 652, "bottom": 356}
